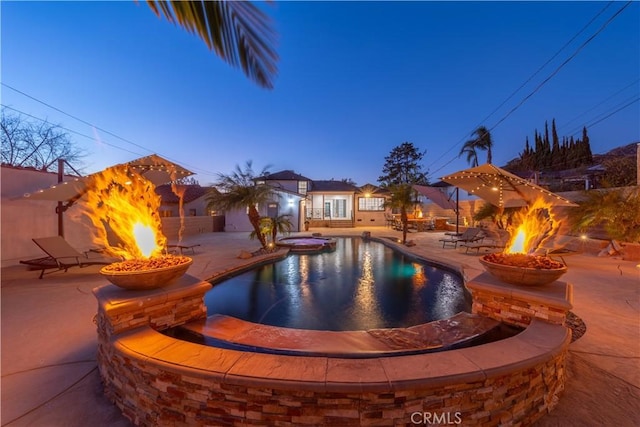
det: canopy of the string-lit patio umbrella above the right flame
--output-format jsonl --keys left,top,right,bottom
{"left": 441, "top": 163, "right": 578, "bottom": 208}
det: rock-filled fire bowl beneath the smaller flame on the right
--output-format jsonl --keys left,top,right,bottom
{"left": 479, "top": 254, "right": 567, "bottom": 286}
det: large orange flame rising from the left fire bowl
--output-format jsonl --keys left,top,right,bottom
{"left": 83, "top": 166, "right": 167, "bottom": 259}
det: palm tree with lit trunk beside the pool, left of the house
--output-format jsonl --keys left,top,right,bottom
{"left": 206, "top": 161, "right": 275, "bottom": 249}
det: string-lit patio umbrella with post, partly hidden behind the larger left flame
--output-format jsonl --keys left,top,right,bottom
{"left": 24, "top": 154, "right": 193, "bottom": 236}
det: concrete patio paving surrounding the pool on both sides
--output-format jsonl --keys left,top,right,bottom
{"left": 0, "top": 231, "right": 640, "bottom": 427}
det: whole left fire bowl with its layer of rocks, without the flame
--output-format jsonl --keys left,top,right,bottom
{"left": 100, "top": 255, "right": 193, "bottom": 290}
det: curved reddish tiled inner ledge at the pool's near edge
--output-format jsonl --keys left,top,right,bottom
{"left": 172, "top": 312, "right": 508, "bottom": 358}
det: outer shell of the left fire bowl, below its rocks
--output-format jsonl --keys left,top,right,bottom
{"left": 100, "top": 257, "right": 193, "bottom": 290}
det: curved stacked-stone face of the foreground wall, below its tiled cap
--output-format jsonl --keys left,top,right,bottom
{"left": 105, "top": 332, "right": 566, "bottom": 426}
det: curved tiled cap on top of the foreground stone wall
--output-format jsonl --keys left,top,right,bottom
{"left": 112, "top": 320, "right": 571, "bottom": 393}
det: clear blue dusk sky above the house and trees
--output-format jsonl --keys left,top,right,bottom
{"left": 0, "top": 1, "right": 640, "bottom": 185}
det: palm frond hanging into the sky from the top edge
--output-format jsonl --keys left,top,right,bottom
{"left": 147, "top": 0, "right": 278, "bottom": 89}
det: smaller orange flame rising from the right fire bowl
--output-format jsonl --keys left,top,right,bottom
{"left": 505, "top": 199, "right": 560, "bottom": 254}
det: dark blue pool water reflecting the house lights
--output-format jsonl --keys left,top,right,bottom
{"left": 205, "top": 238, "right": 471, "bottom": 331}
